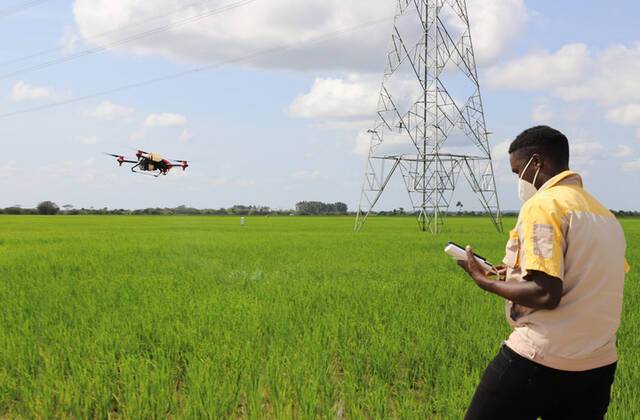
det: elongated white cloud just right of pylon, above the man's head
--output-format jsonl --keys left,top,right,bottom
{"left": 487, "top": 44, "right": 589, "bottom": 90}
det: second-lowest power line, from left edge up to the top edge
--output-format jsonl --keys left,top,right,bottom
{"left": 0, "top": 0, "right": 258, "bottom": 80}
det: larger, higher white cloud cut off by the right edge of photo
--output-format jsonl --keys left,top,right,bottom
{"left": 557, "top": 43, "right": 640, "bottom": 104}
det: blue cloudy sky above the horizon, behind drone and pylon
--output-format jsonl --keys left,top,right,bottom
{"left": 0, "top": 0, "right": 640, "bottom": 210}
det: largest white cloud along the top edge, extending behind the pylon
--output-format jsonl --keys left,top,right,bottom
{"left": 73, "top": 0, "right": 527, "bottom": 71}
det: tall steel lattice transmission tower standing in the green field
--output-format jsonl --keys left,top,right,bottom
{"left": 355, "top": 0, "right": 502, "bottom": 233}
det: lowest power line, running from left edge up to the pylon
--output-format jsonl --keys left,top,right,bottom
{"left": 0, "top": 16, "right": 390, "bottom": 119}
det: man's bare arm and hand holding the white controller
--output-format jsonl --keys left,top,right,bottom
{"left": 459, "top": 247, "right": 562, "bottom": 309}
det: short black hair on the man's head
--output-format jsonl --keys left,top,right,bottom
{"left": 509, "top": 125, "right": 569, "bottom": 166}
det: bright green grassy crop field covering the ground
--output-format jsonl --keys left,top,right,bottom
{"left": 0, "top": 216, "right": 640, "bottom": 419}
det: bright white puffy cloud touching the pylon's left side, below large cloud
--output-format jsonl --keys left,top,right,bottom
{"left": 287, "top": 74, "right": 380, "bottom": 118}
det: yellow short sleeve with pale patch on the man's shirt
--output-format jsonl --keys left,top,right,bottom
{"left": 520, "top": 202, "right": 566, "bottom": 280}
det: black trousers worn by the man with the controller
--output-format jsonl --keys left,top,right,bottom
{"left": 465, "top": 345, "right": 616, "bottom": 420}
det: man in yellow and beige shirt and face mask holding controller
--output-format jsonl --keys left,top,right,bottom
{"left": 460, "top": 126, "right": 629, "bottom": 420}
